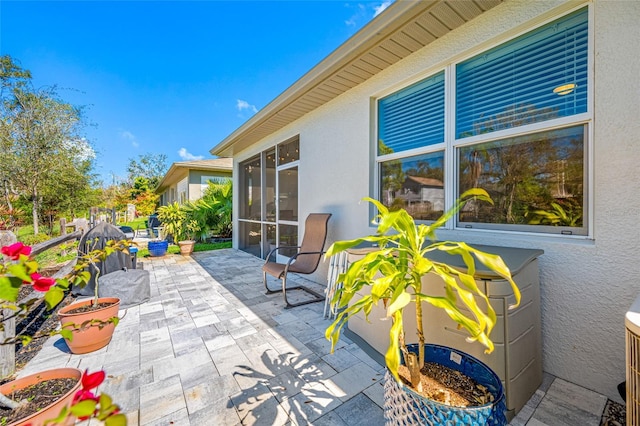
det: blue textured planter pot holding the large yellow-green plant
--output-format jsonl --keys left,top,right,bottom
{"left": 384, "top": 344, "right": 507, "bottom": 426}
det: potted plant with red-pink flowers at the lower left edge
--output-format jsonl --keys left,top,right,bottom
{"left": 0, "top": 242, "right": 126, "bottom": 426}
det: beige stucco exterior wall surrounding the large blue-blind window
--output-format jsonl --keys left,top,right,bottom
{"left": 234, "top": 0, "right": 640, "bottom": 400}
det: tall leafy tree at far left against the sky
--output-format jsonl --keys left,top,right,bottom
{"left": 0, "top": 56, "right": 95, "bottom": 234}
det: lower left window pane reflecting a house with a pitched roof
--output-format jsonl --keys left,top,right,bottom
{"left": 380, "top": 151, "right": 444, "bottom": 220}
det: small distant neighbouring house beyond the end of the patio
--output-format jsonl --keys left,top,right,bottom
{"left": 156, "top": 158, "right": 233, "bottom": 206}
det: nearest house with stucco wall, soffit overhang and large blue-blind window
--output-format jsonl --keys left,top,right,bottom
{"left": 211, "top": 0, "right": 640, "bottom": 401}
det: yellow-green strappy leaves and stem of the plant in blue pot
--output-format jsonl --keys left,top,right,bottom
{"left": 325, "top": 188, "right": 520, "bottom": 390}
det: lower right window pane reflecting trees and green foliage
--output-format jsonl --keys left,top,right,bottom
{"left": 459, "top": 126, "right": 586, "bottom": 233}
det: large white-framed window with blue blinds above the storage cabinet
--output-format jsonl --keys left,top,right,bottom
{"left": 376, "top": 8, "right": 591, "bottom": 235}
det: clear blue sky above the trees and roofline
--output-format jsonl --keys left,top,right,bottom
{"left": 0, "top": 0, "right": 390, "bottom": 184}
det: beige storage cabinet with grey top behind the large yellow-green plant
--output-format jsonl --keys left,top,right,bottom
{"left": 347, "top": 245, "right": 544, "bottom": 419}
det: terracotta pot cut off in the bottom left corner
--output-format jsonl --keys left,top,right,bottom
{"left": 0, "top": 368, "right": 82, "bottom": 426}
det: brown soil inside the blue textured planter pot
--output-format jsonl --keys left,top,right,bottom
{"left": 398, "top": 362, "right": 494, "bottom": 407}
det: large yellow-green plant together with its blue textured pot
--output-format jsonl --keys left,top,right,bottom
{"left": 325, "top": 189, "right": 520, "bottom": 425}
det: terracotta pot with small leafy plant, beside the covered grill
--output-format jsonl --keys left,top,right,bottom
{"left": 58, "top": 240, "right": 129, "bottom": 354}
